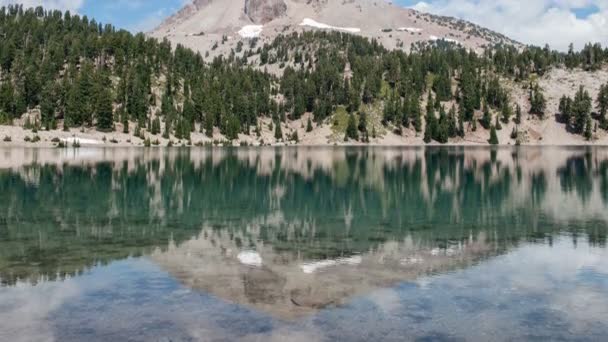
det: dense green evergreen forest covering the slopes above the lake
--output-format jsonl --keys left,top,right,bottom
{"left": 0, "top": 6, "right": 608, "bottom": 143}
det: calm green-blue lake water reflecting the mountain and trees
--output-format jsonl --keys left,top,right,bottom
{"left": 0, "top": 148, "right": 608, "bottom": 342}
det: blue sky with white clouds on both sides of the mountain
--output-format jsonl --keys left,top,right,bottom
{"left": 0, "top": 0, "right": 608, "bottom": 50}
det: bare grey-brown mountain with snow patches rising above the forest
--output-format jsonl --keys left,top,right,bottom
{"left": 151, "top": 0, "right": 519, "bottom": 55}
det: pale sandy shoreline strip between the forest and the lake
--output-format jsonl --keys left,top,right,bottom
{"left": 0, "top": 122, "right": 608, "bottom": 148}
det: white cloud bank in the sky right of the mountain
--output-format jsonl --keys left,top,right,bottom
{"left": 412, "top": 0, "right": 608, "bottom": 50}
